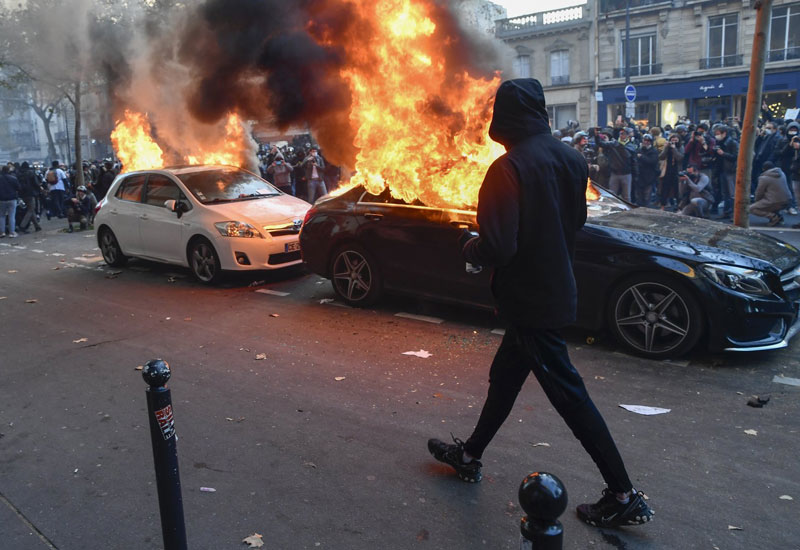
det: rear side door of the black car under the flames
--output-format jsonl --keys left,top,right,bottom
{"left": 354, "top": 189, "right": 442, "bottom": 293}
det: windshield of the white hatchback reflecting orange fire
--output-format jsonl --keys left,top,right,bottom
{"left": 176, "top": 168, "right": 281, "bottom": 204}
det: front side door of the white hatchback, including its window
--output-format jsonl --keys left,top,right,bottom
{"left": 139, "top": 174, "right": 188, "bottom": 263}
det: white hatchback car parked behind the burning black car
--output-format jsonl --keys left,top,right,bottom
{"left": 95, "top": 166, "right": 311, "bottom": 283}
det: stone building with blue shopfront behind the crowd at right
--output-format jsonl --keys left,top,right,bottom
{"left": 597, "top": 0, "right": 800, "bottom": 126}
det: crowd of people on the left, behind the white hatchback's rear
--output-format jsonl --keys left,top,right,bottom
{"left": 0, "top": 159, "right": 120, "bottom": 238}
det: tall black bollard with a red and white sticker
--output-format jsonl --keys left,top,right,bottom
{"left": 142, "top": 359, "right": 186, "bottom": 550}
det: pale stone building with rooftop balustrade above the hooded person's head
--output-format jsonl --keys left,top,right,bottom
{"left": 495, "top": 2, "right": 596, "bottom": 128}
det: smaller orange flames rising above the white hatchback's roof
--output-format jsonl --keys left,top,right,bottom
{"left": 111, "top": 109, "right": 248, "bottom": 172}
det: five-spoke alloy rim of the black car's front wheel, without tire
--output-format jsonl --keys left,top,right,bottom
{"left": 614, "top": 282, "right": 694, "bottom": 354}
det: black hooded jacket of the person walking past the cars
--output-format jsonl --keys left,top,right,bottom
{"left": 464, "top": 78, "right": 589, "bottom": 328}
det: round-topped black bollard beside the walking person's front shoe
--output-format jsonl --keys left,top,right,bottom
{"left": 519, "top": 472, "right": 567, "bottom": 550}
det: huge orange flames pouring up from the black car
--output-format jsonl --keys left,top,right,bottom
{"left": 342, "top": 0, "right": 504, "bottom": 208}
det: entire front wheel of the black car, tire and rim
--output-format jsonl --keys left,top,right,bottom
{"left": 607, "top": 273, "right": 705, "bottom": 359}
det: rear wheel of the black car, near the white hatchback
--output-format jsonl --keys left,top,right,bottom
{"left": 331, "top": 244, "right": 383, "bottom": 306}
